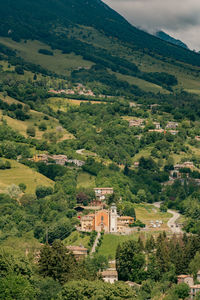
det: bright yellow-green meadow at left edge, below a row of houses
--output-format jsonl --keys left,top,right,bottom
{"left": 0, "top": 160, "right": 54, "bottom": 193}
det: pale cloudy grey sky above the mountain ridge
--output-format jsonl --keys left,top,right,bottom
{"left": 103, "top": 0, "right": 200, "bottom": 51}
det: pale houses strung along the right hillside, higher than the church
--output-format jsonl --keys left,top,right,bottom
{"left": 129, "top": 119, "right": 178, "bottom": 135}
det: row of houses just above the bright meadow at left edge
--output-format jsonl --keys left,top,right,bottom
{"left": 30, "top": 153, "right": 85, "bottom": 167}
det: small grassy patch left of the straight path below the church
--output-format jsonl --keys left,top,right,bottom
{"left": 63, "top": 231, "right": 90, "bottom": 248}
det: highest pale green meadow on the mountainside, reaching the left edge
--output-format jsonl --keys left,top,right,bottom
{"left": 0, "top": 37, "right": 92, "bottom": 75}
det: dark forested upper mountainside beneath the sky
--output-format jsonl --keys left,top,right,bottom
{"left": 0, "top": 0, "right": 200, "bottom": 66}
